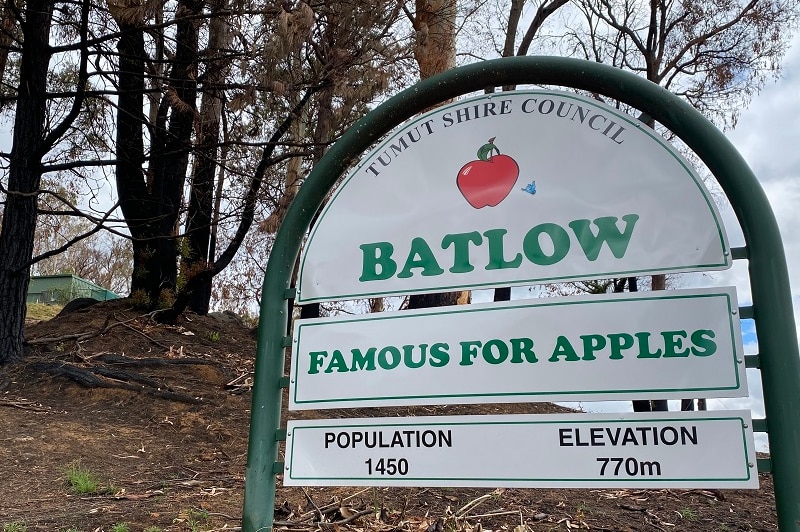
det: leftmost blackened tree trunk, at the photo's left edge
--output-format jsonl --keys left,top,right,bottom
{"left": 0, "top": 0, "right": 53, "bottom": 364}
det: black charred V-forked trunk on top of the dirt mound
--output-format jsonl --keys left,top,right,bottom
{"left": 117, "top": 1, "right": 200, "bottom": 307}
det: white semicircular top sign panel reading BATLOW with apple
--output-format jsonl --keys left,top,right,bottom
{"left": 298, "top": 91, "right": 731, "bottom": 303}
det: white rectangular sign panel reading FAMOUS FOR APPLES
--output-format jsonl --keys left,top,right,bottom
{"left": 289, "top": 288, "right": 747, "bottom": 410}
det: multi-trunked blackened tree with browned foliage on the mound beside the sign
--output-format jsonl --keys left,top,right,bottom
{"left": 111, "top": 0, "right": 406, "bottom": 319}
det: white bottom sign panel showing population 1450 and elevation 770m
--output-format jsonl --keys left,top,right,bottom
{"left": 283, "top": 411, "right": 758, "bottom": 488}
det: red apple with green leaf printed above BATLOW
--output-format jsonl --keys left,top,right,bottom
{"left": 456, "top": 137, "right": 519, "bottom": 209}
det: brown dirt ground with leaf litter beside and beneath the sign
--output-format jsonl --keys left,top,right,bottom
{"left": 0, "top": 300, "right": 777, "bottom": 532}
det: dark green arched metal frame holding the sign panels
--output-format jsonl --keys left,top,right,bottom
{"left": 242, "top": 57, "right": 800, "bottom": 532}
